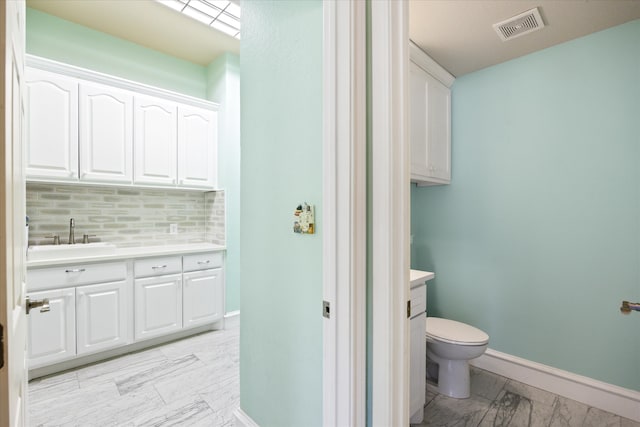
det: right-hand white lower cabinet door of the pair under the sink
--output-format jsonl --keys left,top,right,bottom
{"left": 76, "top": 280, "right": 132, "bottom": 355}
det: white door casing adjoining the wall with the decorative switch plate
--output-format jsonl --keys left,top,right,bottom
{"left": 322, "top": 1, "right": 367, "bottom": 426}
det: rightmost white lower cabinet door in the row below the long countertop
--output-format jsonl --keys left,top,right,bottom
{"left": 183, "top": 268, "right": 224, "bottom": 328}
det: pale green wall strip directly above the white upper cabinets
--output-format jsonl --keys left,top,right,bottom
{"left": 26, "top": 8, "right": 207, "bottom": 98}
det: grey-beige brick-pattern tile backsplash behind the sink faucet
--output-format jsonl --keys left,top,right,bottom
{"left": 27, "top": 183, "right": 225, "bottom": 247}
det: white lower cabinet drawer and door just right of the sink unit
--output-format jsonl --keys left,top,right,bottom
{"left": 134, "top": 257, "right": 182, "bottom": 340}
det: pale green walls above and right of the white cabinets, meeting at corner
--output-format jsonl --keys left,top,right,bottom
{"left": 26, "top": 8, "right": 240, "bottom": 312}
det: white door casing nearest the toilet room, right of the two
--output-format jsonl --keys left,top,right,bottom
{"left": 370, "top": 0, "right": 410, "bottom": 426}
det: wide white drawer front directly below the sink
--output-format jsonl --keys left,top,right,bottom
{"left": 27, "top": 262, "right": 127, "bottom": 291}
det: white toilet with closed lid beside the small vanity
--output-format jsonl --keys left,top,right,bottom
{"left": 426, "top": 317, "right": 489, "bottom": 399}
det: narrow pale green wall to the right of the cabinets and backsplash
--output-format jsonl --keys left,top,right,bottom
{"left": 207, "top": 53, "right": 240, "bottom": 312}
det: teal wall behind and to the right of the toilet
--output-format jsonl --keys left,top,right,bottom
{"left": 412, "top": 21, "right": 640, "bottom": 390}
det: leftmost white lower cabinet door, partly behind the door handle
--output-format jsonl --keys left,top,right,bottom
{"left": 28, "top": 288, "right": 76, "bottom": 369}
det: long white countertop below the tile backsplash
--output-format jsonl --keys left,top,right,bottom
{"left": 27, "top": 243, "right": 226, "bottom": 268}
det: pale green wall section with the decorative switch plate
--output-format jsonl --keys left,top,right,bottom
{"left": 240, "top": 0, "right": 322, "bottom": 427}
